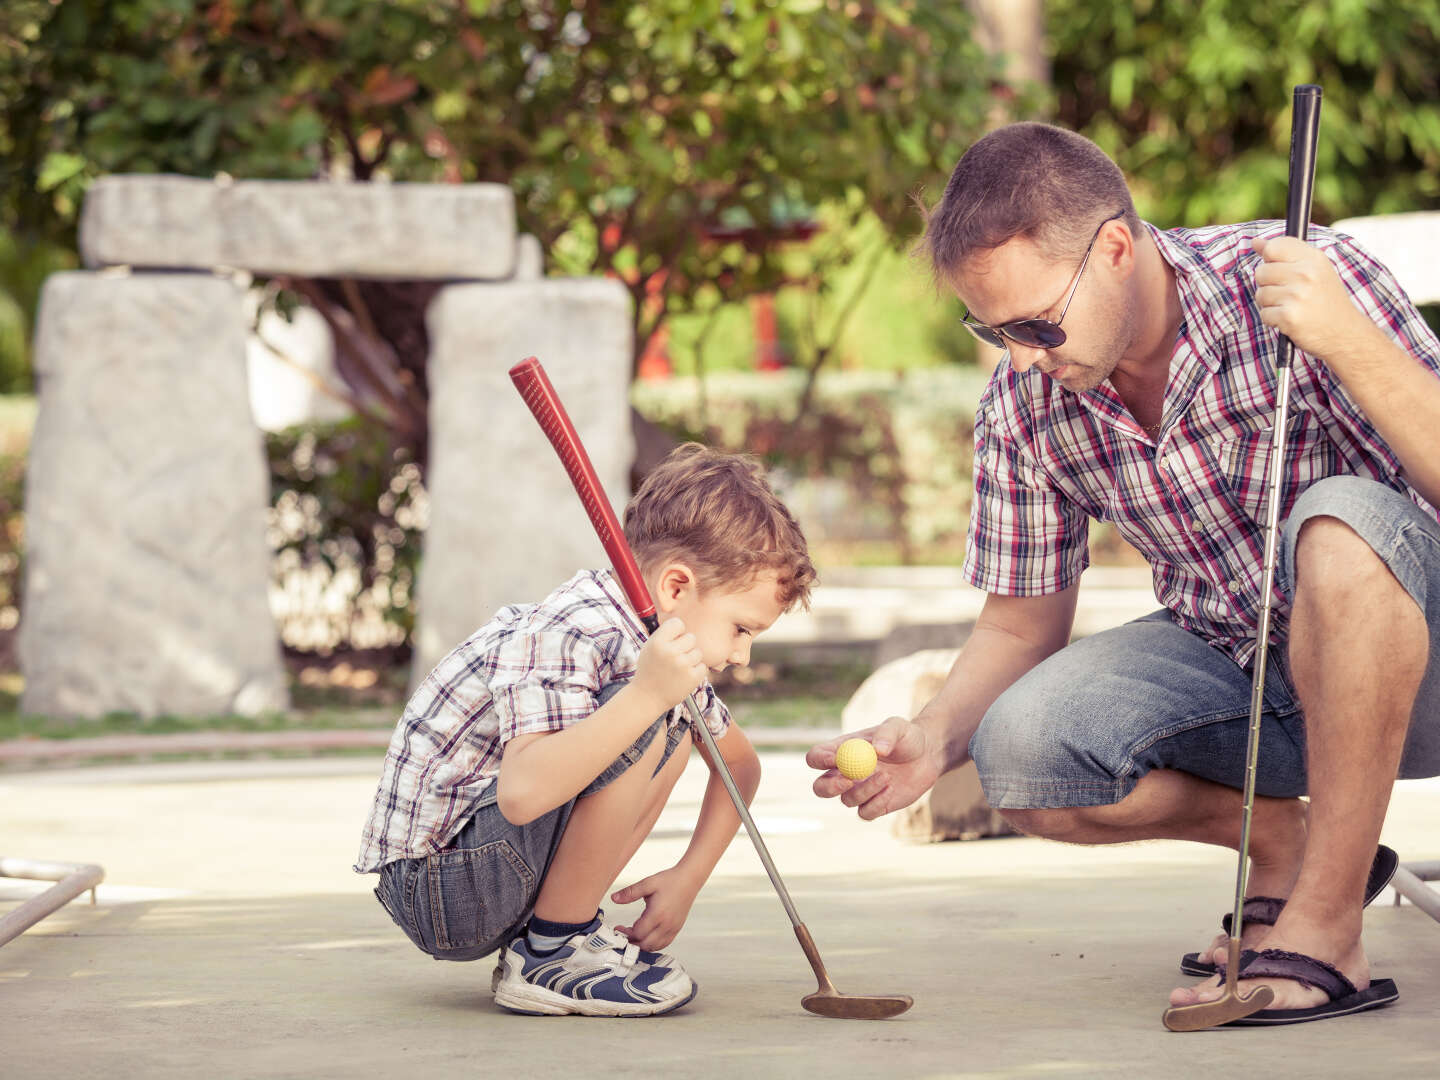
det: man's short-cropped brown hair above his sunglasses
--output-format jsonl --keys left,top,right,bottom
{"left": 922, "top": 122, "right": 1140, "bottom": 285}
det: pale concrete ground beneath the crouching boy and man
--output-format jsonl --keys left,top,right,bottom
{"left": 0, "top": 752, "right": 1440, "bottom": 1080}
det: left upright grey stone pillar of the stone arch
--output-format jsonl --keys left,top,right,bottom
{"left": 19, "top": 272, "right": 288, "bottom": 716}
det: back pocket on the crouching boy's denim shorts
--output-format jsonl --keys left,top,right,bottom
{"left": 426, "top": 840, "right": 537, "bottom": 949}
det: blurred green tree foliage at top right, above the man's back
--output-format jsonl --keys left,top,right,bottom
{"left": 1045, "top": 0, "right": 1440, "bottom": 225}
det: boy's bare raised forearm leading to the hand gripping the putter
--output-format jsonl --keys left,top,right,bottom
{"left": 498, "top": 684, "right": 665, "bottom": 825}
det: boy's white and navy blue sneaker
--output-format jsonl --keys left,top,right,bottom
{"left": 491, "top": 924, "right": 697, "bottom": 1017}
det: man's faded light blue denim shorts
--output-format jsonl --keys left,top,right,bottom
{"left": 971, "top": 477, "right": 1440, "bottom": 809}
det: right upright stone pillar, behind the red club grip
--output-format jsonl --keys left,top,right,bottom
{"left": 412, "top": 278, "right": 635, "bottom": 683}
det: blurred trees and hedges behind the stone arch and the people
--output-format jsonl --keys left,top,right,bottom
{"left": 0, "top": 0, "right": 1440, "bottom": 728}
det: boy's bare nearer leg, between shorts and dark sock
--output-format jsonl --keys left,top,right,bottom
{"left": 534, "top": 732, "right": 684, "bottom": 923}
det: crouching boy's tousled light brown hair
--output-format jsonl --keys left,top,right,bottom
{"left": 625, "top": 442, "right": 815, "bottom": 611}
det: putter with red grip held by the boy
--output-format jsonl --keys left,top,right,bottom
{"left": 510, "top": 357, "right": 914, "bottom": 1020}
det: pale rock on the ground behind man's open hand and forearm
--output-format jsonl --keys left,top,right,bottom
{"left": 841, "top": 649, "right": 1014, "bottom": 842}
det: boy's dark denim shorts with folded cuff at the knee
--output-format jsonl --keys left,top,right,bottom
{"left": 374, "top": 683, "right": 688, "bottom": 960}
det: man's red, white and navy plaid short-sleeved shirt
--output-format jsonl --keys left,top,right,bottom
{"left": 965, "top": 222, "right": 1440, "bottom": 665}
